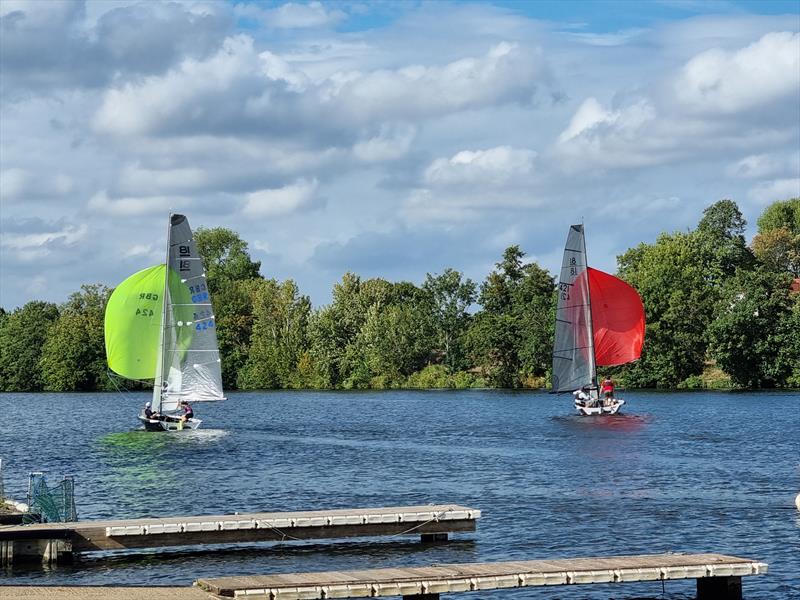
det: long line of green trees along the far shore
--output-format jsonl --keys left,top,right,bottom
{"left": 0, "top": 198, "right": 800, "bottom": 392}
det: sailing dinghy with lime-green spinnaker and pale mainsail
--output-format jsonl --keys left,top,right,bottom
{"left": 105, "top": 214, "right": 225, "bottom": 431}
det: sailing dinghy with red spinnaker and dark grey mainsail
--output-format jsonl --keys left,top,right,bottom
{"left": 553, "top": 225, "right": 644, "bottom": 415}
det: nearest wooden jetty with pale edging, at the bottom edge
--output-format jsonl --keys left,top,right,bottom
{"left": 195, "top": 554, "right": 767, "bottom": 600}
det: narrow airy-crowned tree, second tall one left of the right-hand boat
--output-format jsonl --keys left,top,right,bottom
{"left": 422, "top": 269, "right": 477, "bottom": 373}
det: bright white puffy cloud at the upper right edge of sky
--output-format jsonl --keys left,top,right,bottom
{"left": 674, "top": 31, "right": 800, "bottom": 113}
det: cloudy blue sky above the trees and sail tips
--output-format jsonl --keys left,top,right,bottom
{"left": 0, "top": 0, "right": 800, "bottom": 310}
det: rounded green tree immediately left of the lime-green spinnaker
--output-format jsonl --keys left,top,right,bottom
{"left": 39, "top": 284, "right": 111, "bottom": 392}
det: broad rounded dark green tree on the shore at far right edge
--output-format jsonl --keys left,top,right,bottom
{"left": 709, "top": 269, "right": 800, "bottom": 388}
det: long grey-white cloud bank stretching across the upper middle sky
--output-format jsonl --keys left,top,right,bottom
{"left": 94, "top": 35, "right": 546, "bottom": 140}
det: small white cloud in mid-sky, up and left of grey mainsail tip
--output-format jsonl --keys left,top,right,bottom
{"left": 425, "top": 146, "right": 536, "bottom": 187}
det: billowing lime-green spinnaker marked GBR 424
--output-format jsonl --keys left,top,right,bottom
{"left": 105, "top": 265, "right": 191, "bottom": 379}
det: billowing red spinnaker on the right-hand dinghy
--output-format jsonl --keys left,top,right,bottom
{"left": 587, "top": 267, "right": 644, "bottom": 367}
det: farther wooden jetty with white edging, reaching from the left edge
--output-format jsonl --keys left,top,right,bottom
{"left": 0, "top": 504, "right": 481, "bottom": 565}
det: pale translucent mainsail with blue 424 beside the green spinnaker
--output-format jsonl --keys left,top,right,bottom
{"left": 153, "top": 215, "right": 224, "bottom": 412}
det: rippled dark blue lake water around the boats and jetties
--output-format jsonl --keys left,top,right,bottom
{"left": 0, "top": 391, "right": 800, "bottom": 600}
